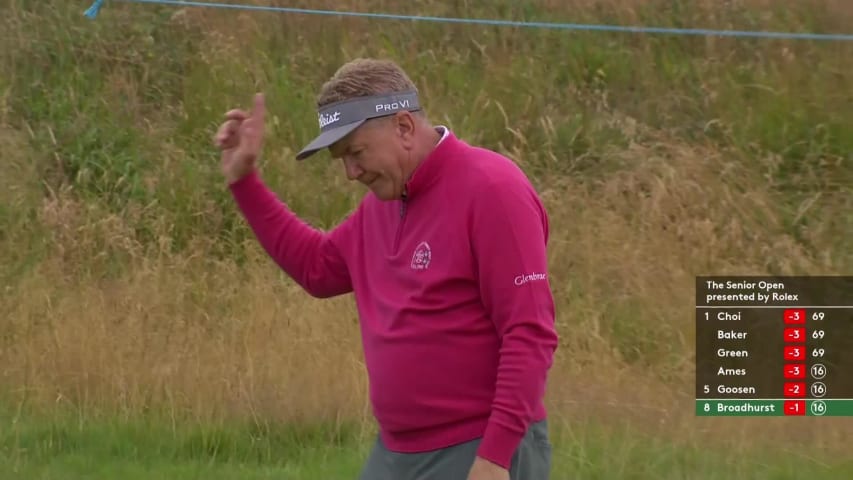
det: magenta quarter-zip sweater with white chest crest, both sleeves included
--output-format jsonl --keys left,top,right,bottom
{"left": 230, "top": 127, "right": 557, "bottom": 468}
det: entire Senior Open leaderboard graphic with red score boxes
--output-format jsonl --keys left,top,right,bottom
{"left": 696, "top": 276, "right": 853, "bottom": 417}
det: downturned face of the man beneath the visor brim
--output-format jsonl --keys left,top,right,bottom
{"left": 329, "top": 115, "right": 408, "bottom": 200}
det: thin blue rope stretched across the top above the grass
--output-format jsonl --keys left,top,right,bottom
{"left": 85, "top": 0, "right": 853, "bottom": 41}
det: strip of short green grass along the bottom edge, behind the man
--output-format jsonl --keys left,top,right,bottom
{"left": 0, "top": 410, "right": 853, "bottom": 480}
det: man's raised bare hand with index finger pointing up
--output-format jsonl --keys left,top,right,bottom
{"left": 213, "top": 93, "right": 266, "bottom": 183}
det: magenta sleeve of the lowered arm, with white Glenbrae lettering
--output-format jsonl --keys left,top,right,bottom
{"left": 471, "top": 173, "right": 558, "bottom": 468}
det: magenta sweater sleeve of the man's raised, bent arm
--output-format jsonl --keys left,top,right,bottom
{"left": 229, "top": 172, "right": 354, "bottom": 298}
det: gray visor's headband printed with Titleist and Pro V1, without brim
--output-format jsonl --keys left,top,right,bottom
{"left": 317, "top": 91, "right": 421, "bottom": 130}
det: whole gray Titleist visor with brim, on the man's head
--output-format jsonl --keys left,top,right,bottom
{"left": 296, "top": 91, "right": 421, "bottom": 160}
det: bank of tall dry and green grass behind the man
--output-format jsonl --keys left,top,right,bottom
{"left": 0, "top": 0, "right": 853, "bottom": 478}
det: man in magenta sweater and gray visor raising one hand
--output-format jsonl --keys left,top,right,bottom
{"left": 215, "top": 59, "right": 557, "bottom": 480}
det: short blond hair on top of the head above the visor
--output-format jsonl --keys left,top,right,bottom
{"left": 317, "top": 58, "right": 417, "bottom": 108}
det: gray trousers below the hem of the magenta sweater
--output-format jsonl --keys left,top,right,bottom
{"left": 359, "top": 420, "right": 551, "bottom": 480}
